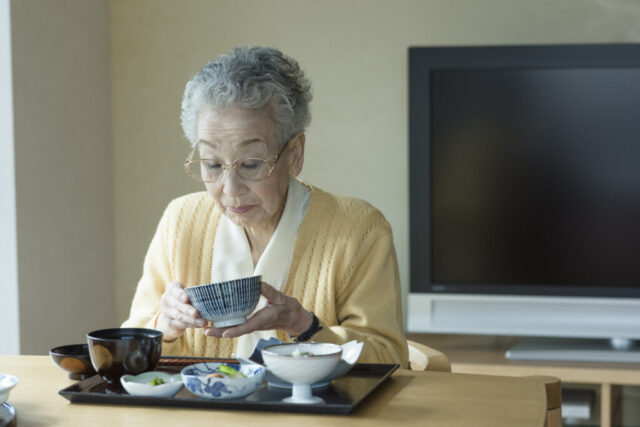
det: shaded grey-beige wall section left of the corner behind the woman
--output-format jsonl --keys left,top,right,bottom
{"left": 11, "top": 0, "right": 115, "bottom": 354}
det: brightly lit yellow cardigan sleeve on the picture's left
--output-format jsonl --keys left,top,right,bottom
{"left": 121, "top": 204, "right": 184, "bottom": 355}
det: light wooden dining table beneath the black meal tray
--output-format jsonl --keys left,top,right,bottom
{"left": 0, "top": 356, "right": 546, "bottom": 427}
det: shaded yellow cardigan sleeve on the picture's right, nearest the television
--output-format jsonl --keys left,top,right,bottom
{"left": 312, "top": 230, "right": 408, "bottom": 367}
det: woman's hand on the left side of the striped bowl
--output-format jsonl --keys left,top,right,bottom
{"left": 156, "top": 282, "right": 208, "bottom": 342}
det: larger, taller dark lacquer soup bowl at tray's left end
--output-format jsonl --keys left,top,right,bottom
{"left": 87, "top": 328, "right": 162, "bottom": 384}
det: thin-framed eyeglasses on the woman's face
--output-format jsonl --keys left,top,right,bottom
{"left": 184, "top": 141, "right": 289, "bottom": 182}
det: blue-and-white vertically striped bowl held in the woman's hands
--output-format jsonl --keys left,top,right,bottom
{"left": 185, "top": 276, "right": 262, "bottom": 328}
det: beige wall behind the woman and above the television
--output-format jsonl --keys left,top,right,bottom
{"left": 111, "top": 0, "right": 640, "bottom": 321}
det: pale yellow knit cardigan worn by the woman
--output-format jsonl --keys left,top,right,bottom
{"left": 122, "top": 184, "right": 407, "bottom": 366}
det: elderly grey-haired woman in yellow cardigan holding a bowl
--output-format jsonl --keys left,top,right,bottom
{"left": 123, "top": 47, "right": 407, "bottom": 366}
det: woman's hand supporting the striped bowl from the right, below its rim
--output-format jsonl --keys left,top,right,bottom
{"left": 204, "top": 282, "right": 313, "bottom": 338}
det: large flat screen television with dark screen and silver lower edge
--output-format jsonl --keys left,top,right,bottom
{"left": 407, "top": 44, "right": 640, "bottom": 361}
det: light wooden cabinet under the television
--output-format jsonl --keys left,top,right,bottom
{"left": 407, "top": 333, "right": 640, "bottom": 427}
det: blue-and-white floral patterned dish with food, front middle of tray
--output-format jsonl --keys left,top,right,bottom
{"left": 180, "top": 362, "right": 266, "bottom": 399}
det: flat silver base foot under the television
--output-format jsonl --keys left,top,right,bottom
{"left": 505, "top": 338, "right": 640, "bottom": 363}
